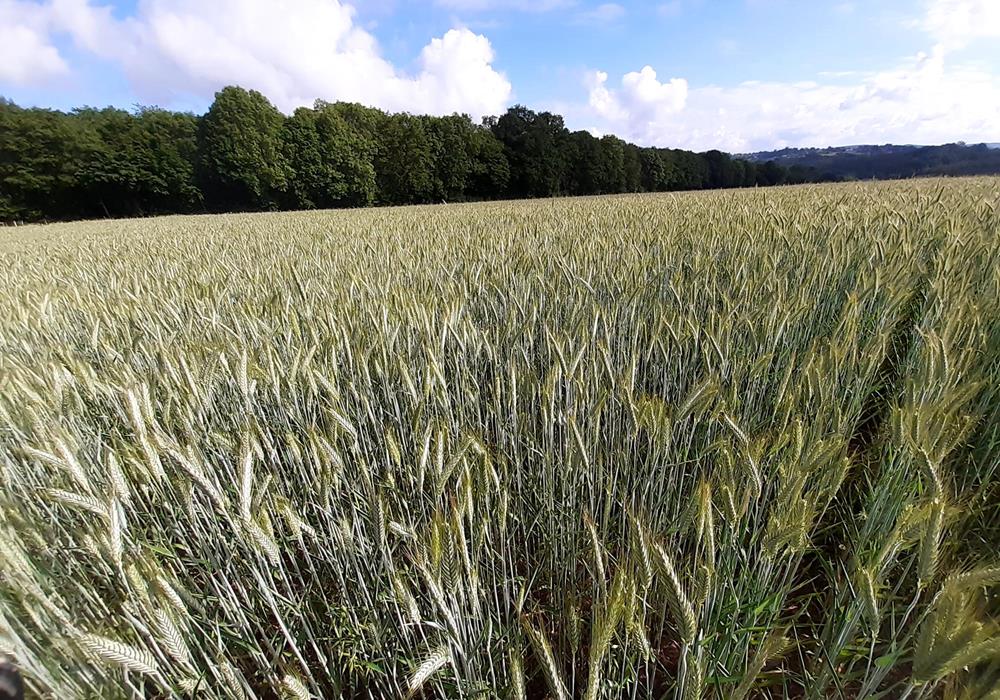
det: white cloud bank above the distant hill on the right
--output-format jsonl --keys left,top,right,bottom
{"left": 580, "top": 0, "right": 1000, "bottom": 152}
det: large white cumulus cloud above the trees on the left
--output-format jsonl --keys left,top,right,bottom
{"left": 0, "top": 0, "right": 511, "bottom": 117}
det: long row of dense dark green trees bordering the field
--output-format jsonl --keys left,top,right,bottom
{"left": 0, "top": 87, "right": 832, "bottom": 221}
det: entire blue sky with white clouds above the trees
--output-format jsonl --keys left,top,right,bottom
{"left": 0, "top": 0, "right": 1000, "bottom": 153}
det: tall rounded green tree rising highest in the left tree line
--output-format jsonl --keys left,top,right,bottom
{"left": 200, "top": 87, "right": 290, "bottom": 210}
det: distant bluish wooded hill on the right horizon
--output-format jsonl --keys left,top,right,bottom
{"left": 737, "top": 143, "right": 1000, "bottom": 180}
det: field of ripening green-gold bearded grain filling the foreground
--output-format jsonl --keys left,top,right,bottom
{"left": 0, "top": 178, "right": 1000, "bottom": 700}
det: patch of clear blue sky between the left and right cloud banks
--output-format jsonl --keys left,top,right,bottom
{"left": 359, "top": 0, "right": 926, "bottom": 104}
